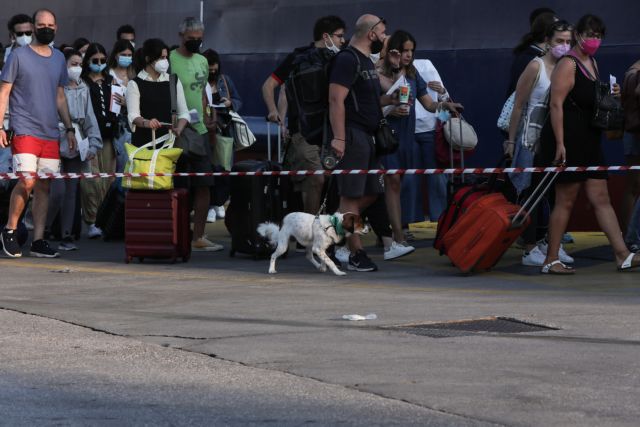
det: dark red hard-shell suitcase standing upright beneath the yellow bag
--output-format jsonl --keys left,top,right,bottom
{"left": 125, "top": 189, "right": 191, "bottom": 263}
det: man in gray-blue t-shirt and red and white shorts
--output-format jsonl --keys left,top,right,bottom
{"left": 0, "top": 9, "right": 76, "bottom": 258}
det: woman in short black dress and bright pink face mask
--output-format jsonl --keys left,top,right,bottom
{"left": 541, "top": 15, "right": 640, "bottom": 274}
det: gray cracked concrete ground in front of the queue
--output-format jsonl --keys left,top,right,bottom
{"left": 0, "top": 222, "right": 640, "bottom": 426}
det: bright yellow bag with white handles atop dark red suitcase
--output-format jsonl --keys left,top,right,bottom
{"left": 122, "top": 131, "right": 182, "bottom": 190}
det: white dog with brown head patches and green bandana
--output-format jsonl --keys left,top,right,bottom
{"left": 258, "top": 212, "right": 368, "bottom": 276}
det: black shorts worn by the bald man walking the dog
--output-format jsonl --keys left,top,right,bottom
{"left": 336, "top": 128, "right": 384, "bottom": 199}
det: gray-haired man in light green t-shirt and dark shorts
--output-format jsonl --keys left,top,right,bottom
{"left": 169, "top": 18, "right": 224, "bottom": 251}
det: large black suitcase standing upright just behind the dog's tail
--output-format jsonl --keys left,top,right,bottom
{"left": 225, "top": 160, "right": 290, "bottom": 259}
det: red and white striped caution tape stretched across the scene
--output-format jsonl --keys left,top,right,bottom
{"left": 0, "top": 165, "right": 640, "bottom": 181}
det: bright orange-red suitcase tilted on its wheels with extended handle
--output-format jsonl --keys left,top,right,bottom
{"left": 443, "top": 172, "right": 558, "bottom": 273}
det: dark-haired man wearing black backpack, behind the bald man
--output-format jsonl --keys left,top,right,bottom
{"left": 262, "top": 16, "right": 345, "bottom": 215}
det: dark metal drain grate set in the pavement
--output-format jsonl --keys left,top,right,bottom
{"left": 382, "top": 317, "right": 558, "bottom": 338}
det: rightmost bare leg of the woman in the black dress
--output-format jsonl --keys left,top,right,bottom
{"left": 585, "top": 179, "right": 630, "bottom": 265}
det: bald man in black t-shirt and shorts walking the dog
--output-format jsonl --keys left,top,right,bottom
{"left": 329, "top": 15, "right": 397, "bottom": 271}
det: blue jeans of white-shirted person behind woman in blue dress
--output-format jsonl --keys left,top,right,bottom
{"left": 416, "top": 131, "right": 447, "bottom": 221}
